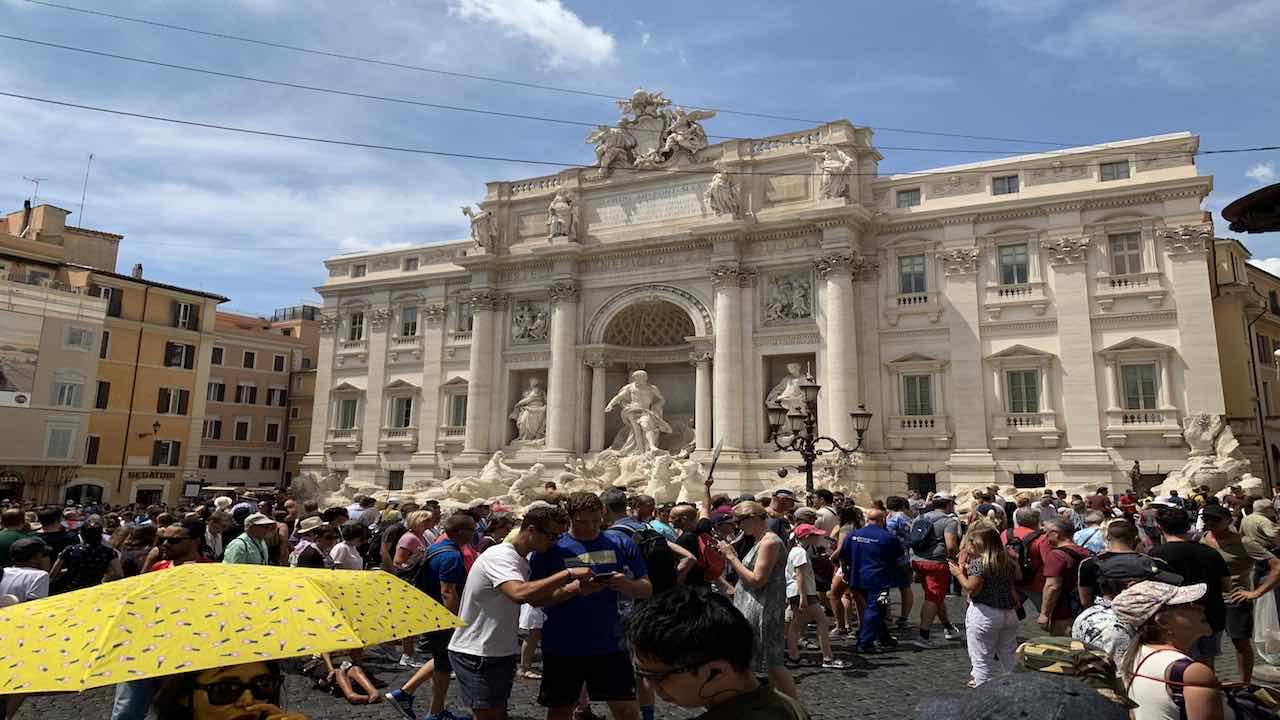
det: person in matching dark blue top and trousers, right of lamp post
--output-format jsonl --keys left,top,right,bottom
{"left": 840, "top": 510, "right": 902, "bottom": 652}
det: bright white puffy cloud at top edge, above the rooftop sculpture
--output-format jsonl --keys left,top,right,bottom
{"left": 449, "top": 0, "right": 617, "bottom": 67}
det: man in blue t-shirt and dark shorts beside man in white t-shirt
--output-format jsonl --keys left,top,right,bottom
{"left": 530, "top": 492, "right": 653, "bottom": 720}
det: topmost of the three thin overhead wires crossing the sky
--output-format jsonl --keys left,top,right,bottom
{"left": 26, "top": 0, "right": 1085, "bottom": 147}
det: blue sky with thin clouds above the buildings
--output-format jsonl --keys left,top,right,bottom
{"left": 0, "top": 0, "right": 1280, "bottom": 313}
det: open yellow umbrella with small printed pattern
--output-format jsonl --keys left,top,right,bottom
{"left": 0, "top": 564, "right": 462, "bottom": 694}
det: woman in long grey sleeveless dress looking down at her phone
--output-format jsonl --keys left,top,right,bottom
{"left": 717, "top": 501, "right": 797, "bottom": 698}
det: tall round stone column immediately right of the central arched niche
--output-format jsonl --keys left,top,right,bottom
{"left": 711, "top": 265, "right": 755, "bottom": 451}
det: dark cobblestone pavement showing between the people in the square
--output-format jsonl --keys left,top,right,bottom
{"left": 18, "top": 588, "right": 1262, "bottom": 720}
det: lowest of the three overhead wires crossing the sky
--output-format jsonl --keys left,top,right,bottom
{"left": 0, "top": 91, "right": 1280, "bottom": 177}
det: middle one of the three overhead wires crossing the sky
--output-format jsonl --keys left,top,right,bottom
{"left": 0, "top": 33, "right": 1049, "bottom": 155}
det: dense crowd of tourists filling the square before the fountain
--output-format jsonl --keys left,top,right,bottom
{"left": 0, "top": 483, "right": 1280, "bottom": 720}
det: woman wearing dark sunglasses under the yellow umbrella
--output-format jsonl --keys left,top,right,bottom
{"left": 151, "top": 662, "right": 308, "bottom": 720}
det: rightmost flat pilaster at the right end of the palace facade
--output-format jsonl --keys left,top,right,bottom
{"left": 1161, "top": 225, "right": 1223, "bottom": 415}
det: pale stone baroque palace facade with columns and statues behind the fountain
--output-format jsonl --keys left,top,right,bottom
{"left": 302, "top": 91, "right": 1224, "bottom": 493}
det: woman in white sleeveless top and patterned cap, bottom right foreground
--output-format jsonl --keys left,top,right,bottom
{"left": 1111, "top": 580, "right": 1234, "bottom": 720}
